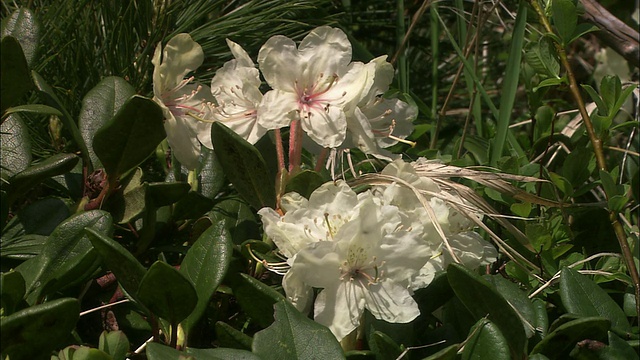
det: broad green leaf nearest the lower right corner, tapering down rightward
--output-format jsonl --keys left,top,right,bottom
{"left": 560, "top": 267, "right": 631, "bottom": 332}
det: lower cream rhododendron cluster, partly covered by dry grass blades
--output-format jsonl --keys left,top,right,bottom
{"left": 258, "top": 160, "right": 496, "bottom": 340}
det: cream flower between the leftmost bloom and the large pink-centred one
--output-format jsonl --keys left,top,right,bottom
{"left": 205, "top": 39, "right": 267, "bottom": 145}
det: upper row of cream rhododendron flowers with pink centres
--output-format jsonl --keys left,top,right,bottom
{"left": 153, "top": 26, "right": 417, "bottom": 169}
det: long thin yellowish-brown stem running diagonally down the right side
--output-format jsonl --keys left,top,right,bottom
{"left": 528, "top": 0, "right": 640, "bottom": 322}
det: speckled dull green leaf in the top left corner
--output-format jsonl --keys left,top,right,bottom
{"left": 2, "top": 8, "right": 40, "bottom": 66}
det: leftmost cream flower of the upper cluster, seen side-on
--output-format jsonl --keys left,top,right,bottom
{"left": 152, "top": 34, "right": 213, "bottom": 170}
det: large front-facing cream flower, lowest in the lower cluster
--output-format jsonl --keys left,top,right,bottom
{"left": 283, "top": 192, "right": 430, "bottom": 340}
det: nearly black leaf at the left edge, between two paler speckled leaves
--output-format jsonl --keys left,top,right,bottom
{"left": 0, "top": 36, "right": 33, "bottom": 113}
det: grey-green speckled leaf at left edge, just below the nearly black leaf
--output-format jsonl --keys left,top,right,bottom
{"left": 0, "top": 114, "right": 31, "bottom": 179}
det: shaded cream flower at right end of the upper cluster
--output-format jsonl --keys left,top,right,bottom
{"left": 347, "top": 55, "right": 418, "bottom": 159}
